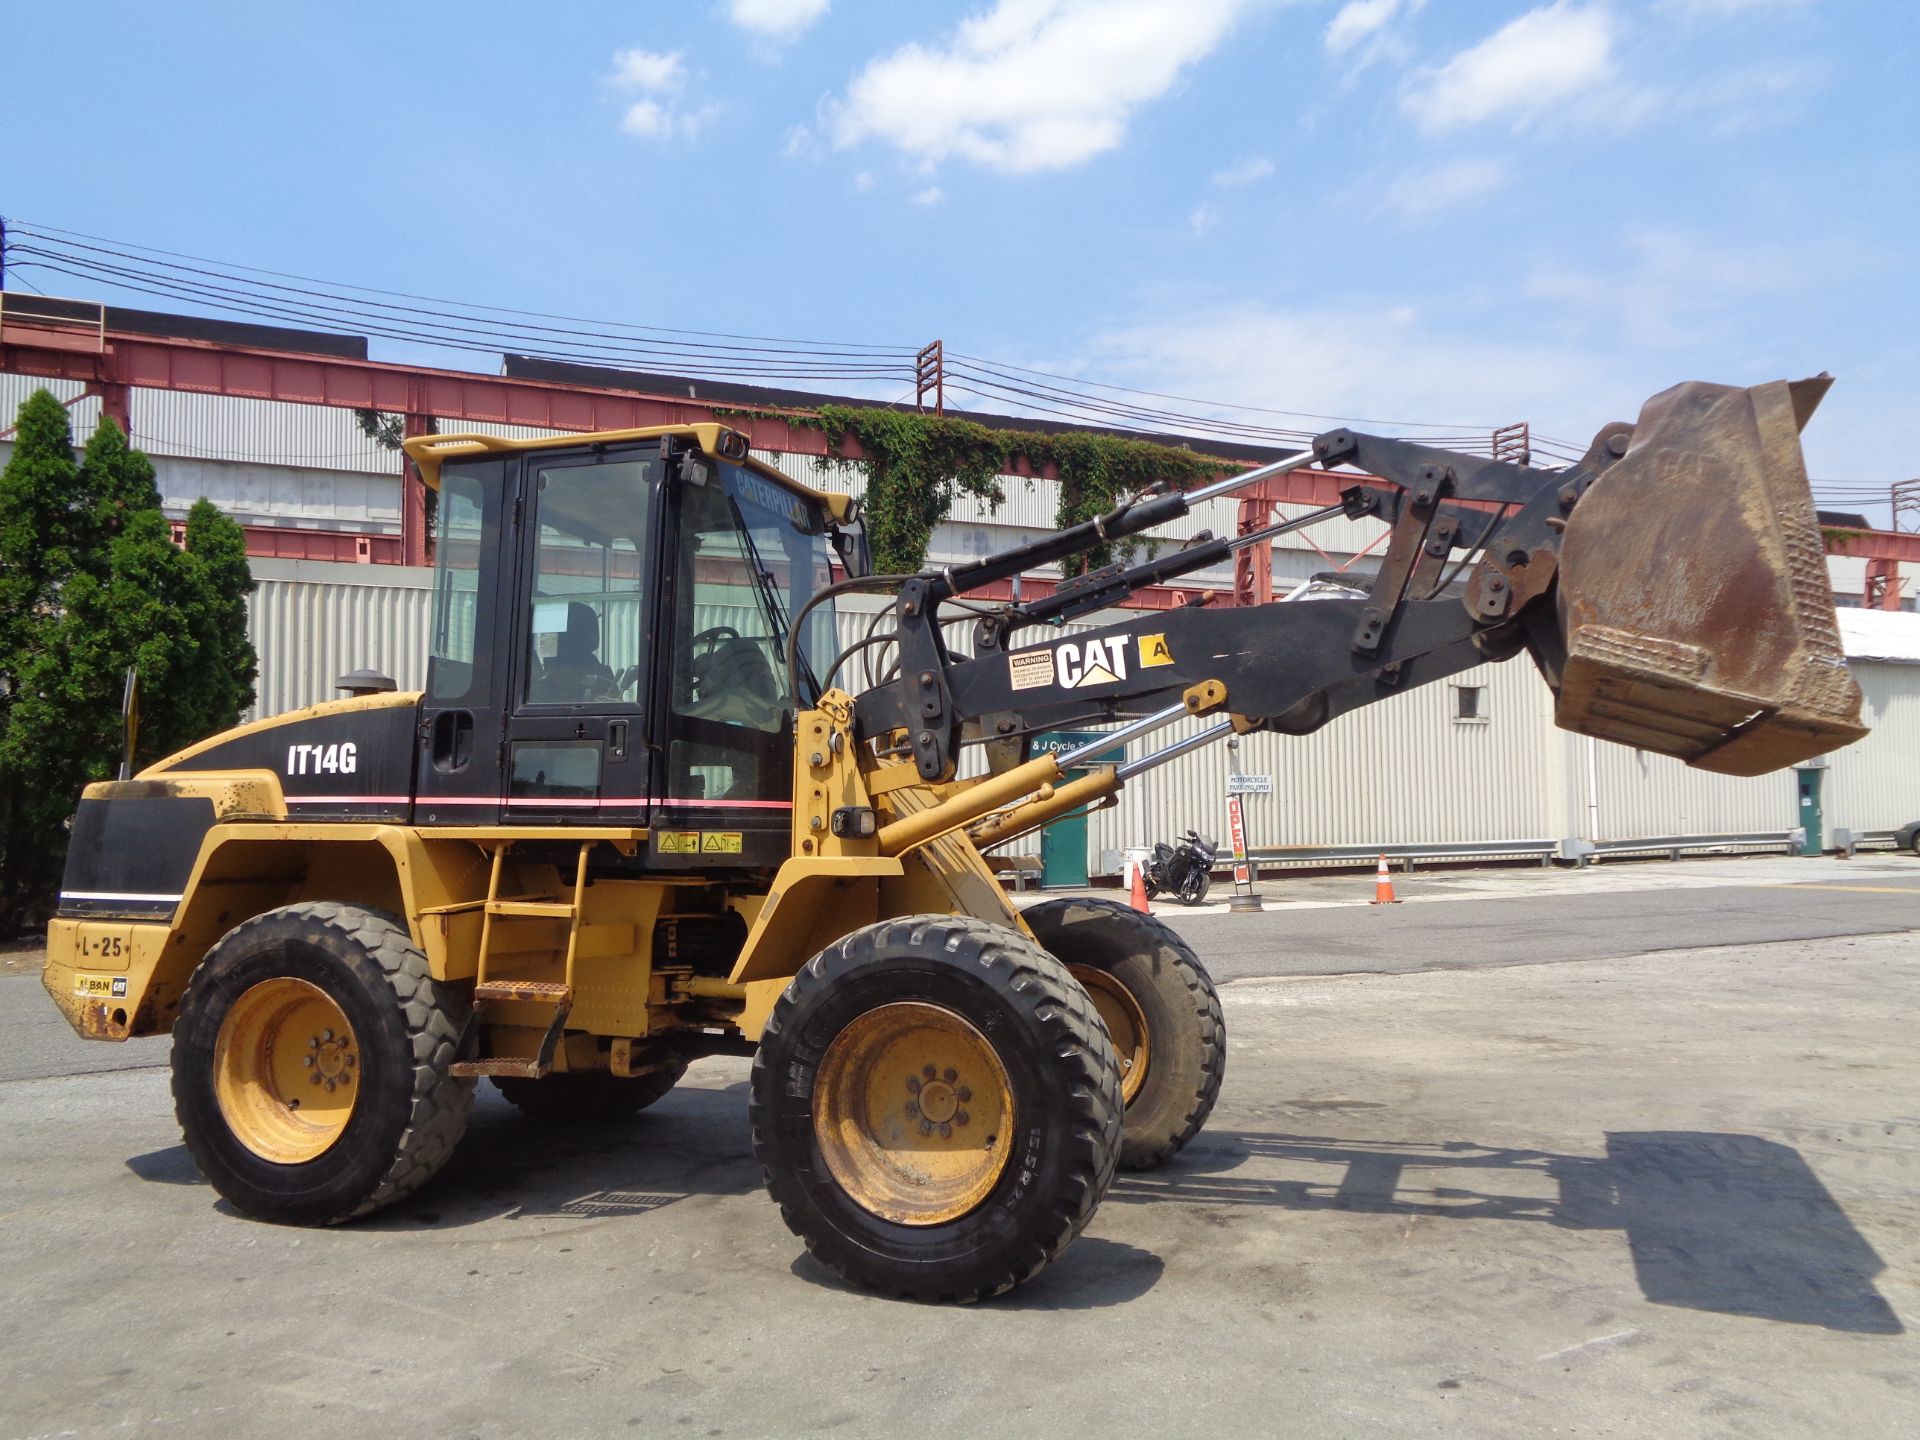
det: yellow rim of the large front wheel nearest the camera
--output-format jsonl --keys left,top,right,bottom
{"left": 814, "top": 1002, "right": 1014, "bottom": 1225}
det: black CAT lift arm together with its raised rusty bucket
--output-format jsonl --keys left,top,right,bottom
{"left": 854, "top": 376, "right": 1864, "bottom": 839}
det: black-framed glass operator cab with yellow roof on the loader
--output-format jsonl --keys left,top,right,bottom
{"left": 409, "top": 426, "right": 860, "bottom": 870}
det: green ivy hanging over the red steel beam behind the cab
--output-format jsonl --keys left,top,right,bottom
{"left": 716, "top": 405, "right": 1235, "bottom": 574}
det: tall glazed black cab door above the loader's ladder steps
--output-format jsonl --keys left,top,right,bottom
{"left": 501, "top": 444, "right": 660, "bottom": 826}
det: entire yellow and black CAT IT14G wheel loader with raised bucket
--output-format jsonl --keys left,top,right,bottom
{"left": 46, "top": 376, "right": 1862, "bottom": 1300}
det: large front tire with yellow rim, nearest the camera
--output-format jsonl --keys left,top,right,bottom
{"left": 751, "top": 916, "right": 1123, "bottom": 1302}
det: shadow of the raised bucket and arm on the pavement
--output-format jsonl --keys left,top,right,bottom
{"left": 1108, "top": 1131, "right": 1905, "bottom": 1334}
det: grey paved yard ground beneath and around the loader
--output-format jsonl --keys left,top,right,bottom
{"left": 0, "top": 856, "right": 1920, "bottom": 1440}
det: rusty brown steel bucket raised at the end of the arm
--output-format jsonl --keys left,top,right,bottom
{"left": 1555, "top": 376, "right": 1866, "bottom": 776}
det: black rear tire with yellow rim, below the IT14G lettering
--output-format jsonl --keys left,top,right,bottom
{"left": 173, "top": 902, "right": 474, "bottom": 1225}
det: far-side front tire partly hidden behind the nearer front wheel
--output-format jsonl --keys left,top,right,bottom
{"left": 1020, "top": 899, "right": 1227, "bottom": 1169}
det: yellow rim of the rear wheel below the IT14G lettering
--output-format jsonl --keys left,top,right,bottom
{"left": 213, "top": 975, "right": 363, "bottom": 1165}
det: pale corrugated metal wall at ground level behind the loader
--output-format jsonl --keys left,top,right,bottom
{"left": 252, "top": 561, "right": 1920, "bottom": 872}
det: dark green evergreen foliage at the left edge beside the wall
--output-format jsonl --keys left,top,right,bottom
{"left": 0, "top": 390, "right": 257, "bottom": 933}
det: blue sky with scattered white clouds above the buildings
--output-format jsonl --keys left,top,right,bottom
{"left": 0, "top": 0, "right": 1920, "bottom": 518}
